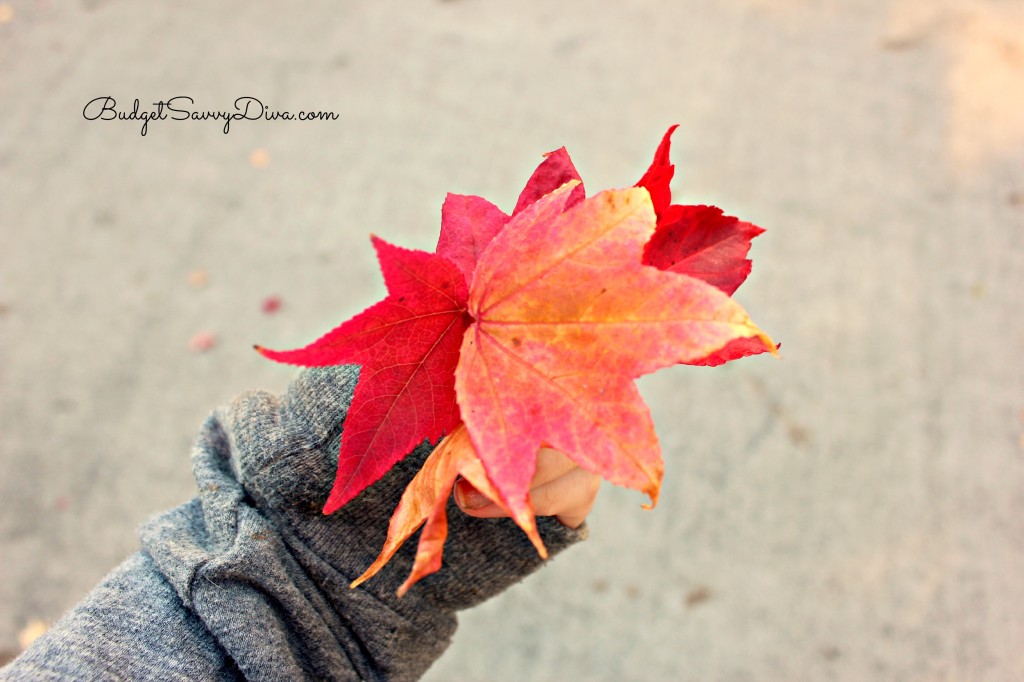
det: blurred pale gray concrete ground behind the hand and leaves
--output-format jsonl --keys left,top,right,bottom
{"left": 0, "top": 0, "right": 1024, "bottom": 681}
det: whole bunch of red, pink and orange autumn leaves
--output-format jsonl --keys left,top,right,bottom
{"left": 257, "top": 126, "right": 776, "bottom": 595}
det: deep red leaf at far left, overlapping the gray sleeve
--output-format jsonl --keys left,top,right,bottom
{"left": 257, "top": 238, "right": 468, "bottom": 514}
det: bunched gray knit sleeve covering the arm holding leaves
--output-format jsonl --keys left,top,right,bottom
{"left": 0, "top": 367, "right": 586, "bottom": 680}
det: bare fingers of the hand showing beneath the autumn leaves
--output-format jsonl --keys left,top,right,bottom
{"left": 455, "top": 447, "right": 601, "bottom": 528}
